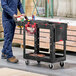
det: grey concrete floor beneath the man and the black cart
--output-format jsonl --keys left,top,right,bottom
{"left": 0, "top": 42, "right": 76, "bottom": 76}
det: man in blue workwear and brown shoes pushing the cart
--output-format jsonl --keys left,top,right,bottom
{"left": 1, "top": 0, "right": 25, "bottom": 63}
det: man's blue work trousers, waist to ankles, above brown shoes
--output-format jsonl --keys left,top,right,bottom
{"left": 2, "top": 20, "right": 16, "bottom": 58}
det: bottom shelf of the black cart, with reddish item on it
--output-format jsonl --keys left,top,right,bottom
{"left": 24, "top": 53, "right": 66, "bottom": 63}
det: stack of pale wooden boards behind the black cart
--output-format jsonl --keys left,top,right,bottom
{"left": 13, "top": 26, "right": 76, "bottom": 52}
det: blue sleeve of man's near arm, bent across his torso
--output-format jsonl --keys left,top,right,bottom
{"left": 1, "top": 0, "right": 15, "bottom": 17}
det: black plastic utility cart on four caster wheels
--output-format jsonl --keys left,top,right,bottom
{"left": 15, "top": 20, "right": 67, "bottom": 69}
